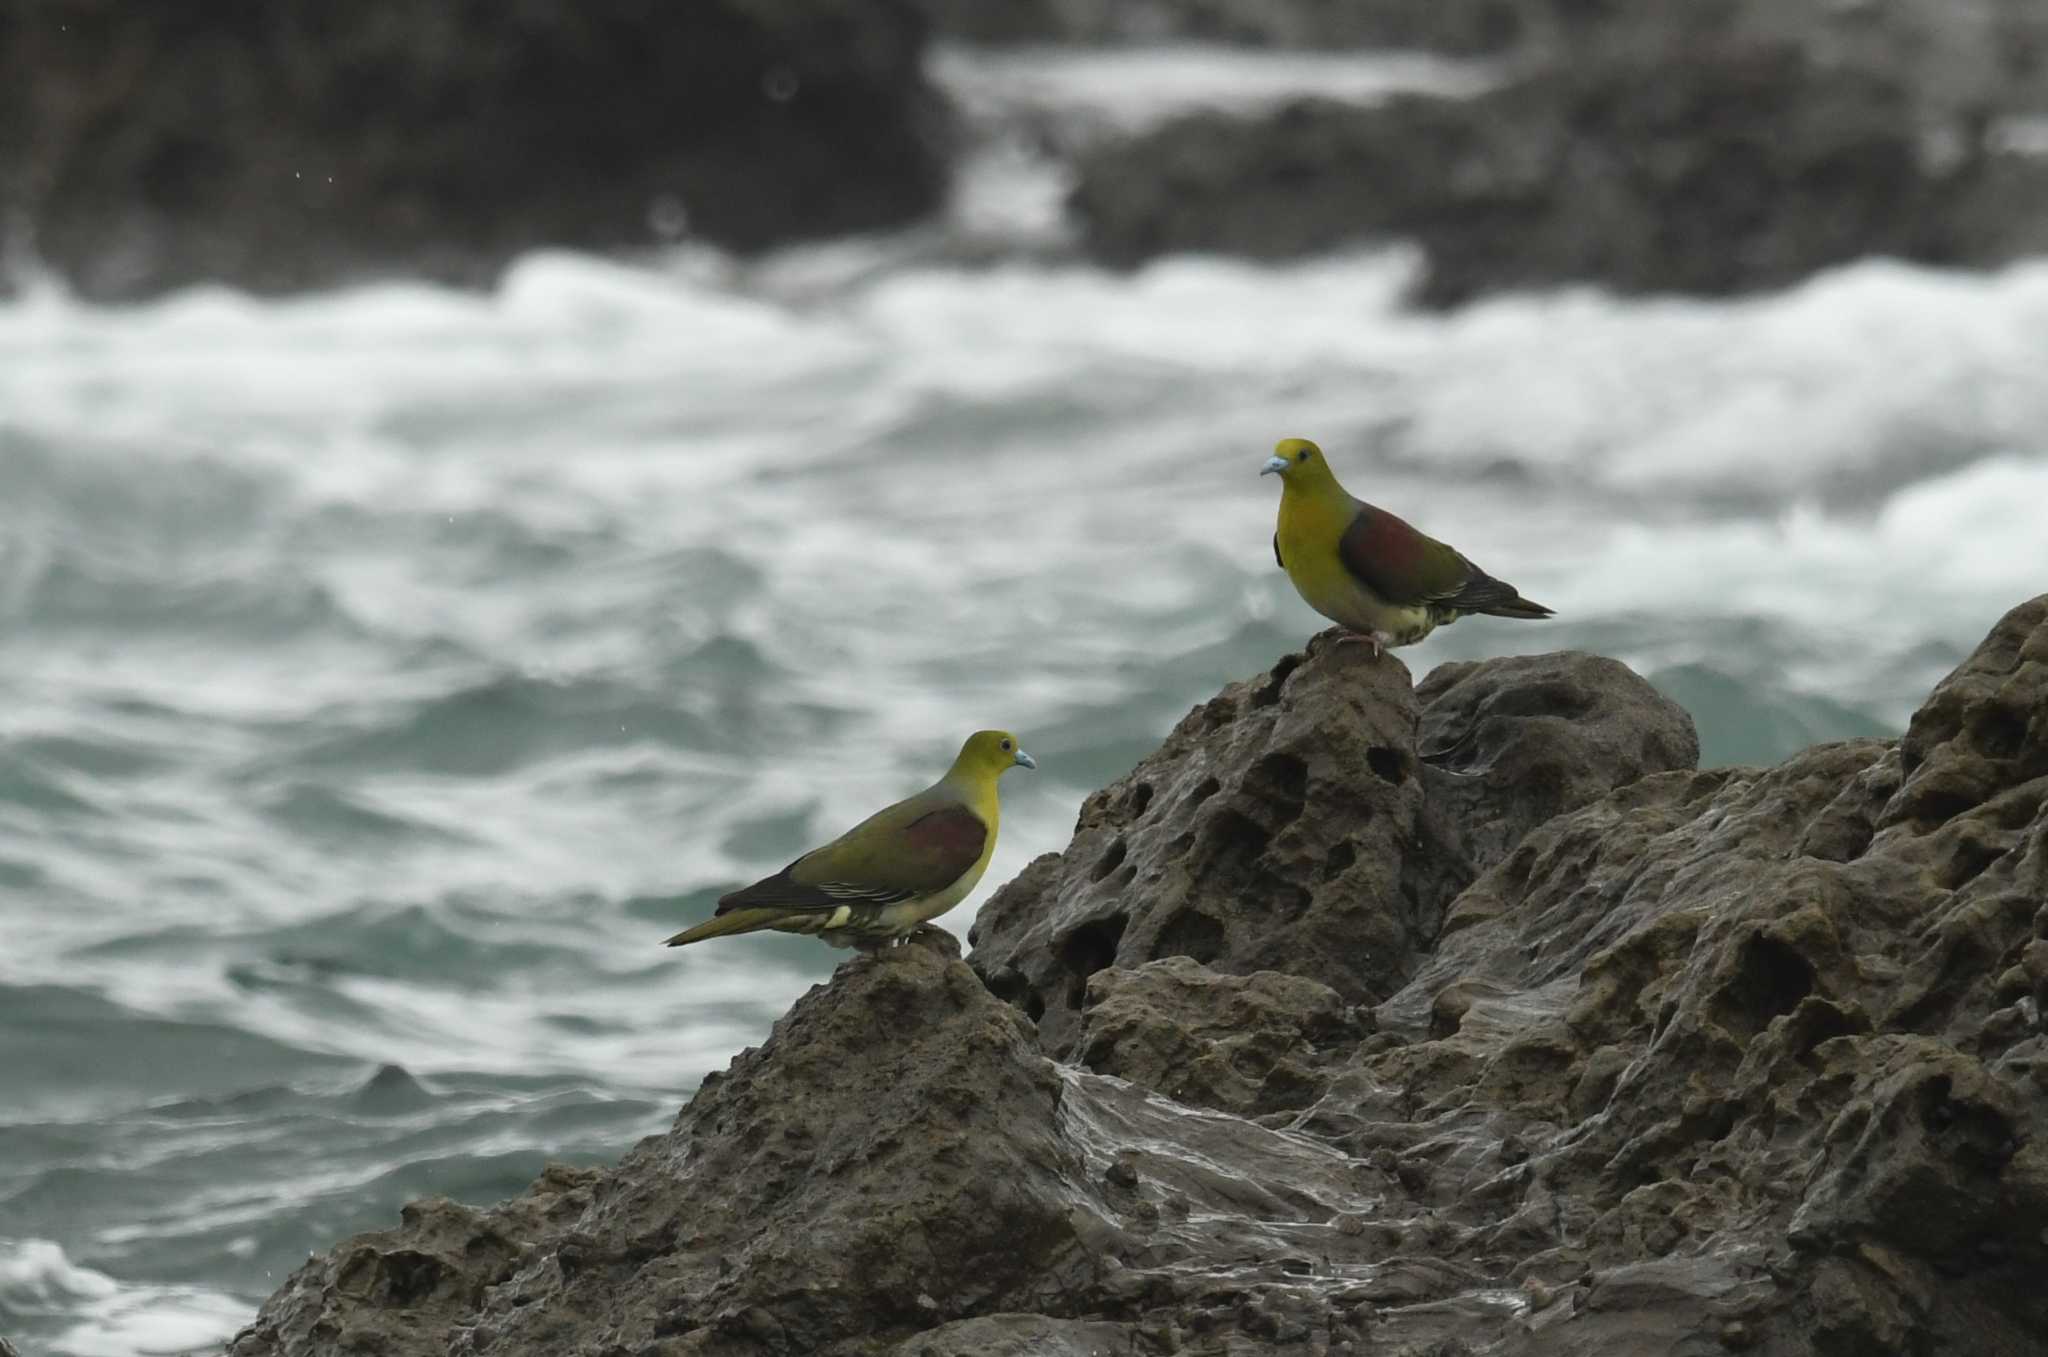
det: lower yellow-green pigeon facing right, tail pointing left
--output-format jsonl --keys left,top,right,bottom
{"left": 668, "top": 731, "right": 1038, "bottom": 948}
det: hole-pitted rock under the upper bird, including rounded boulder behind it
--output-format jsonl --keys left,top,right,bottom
{"left": 969, "top": 632, "right": 1698, "bottom": 1056}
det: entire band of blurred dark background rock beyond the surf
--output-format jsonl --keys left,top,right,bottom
{"left": 0, "top": 0, "right": 2048, "bottom": 305}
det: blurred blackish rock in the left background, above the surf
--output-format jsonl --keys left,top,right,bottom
{"left": 0, "top": 0, "right": 946, "bottom": 299}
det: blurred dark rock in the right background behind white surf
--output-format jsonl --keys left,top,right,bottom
{"left": 1073, "top": 0, "right": 2048, "bottom": 305}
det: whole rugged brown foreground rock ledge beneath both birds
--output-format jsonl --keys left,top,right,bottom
{"left": 231, "top": 596, "right": 2048, "bottom": 1357}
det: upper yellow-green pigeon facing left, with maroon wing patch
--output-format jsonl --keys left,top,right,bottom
{"left": 1260, "top": 438, "right": 1550, "bottom": 655}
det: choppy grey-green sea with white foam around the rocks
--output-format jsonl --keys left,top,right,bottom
{"left": 0, "top": 47, "right": 2048, "bottom": 1357}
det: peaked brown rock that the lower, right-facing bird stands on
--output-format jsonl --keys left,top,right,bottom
{"left": 231, "top": 948, "right": 1106, "bottom": 1357}
